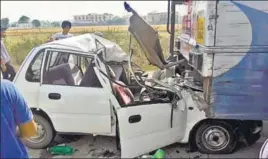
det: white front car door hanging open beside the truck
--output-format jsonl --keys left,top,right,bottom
{"left": 117, "top": 99, "right": 187, "bottom": 158}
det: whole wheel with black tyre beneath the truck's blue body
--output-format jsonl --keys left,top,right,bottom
{"left": 195, "top": 121, "right": 237, "bottom": 154}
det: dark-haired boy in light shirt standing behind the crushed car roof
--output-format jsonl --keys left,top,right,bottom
{"left": 49, "top": 21, "right": 73, "bottom": 41}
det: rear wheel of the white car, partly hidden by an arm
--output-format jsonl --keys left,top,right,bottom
{"left": 23, "top": 114, "right": 56, "bottom": 149}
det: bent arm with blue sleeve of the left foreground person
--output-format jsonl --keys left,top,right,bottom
{"left": 13, "top": 86, "right": 37, "bottom": 138}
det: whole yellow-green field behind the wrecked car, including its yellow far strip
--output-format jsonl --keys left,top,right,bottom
{"left": 4, "top": 26, "right": 176, "bottom": 70}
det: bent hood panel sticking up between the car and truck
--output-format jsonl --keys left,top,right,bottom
{"left": 128, "top": 12, "right": 167, "bottom": 69}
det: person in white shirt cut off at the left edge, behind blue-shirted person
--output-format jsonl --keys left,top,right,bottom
{"left": 1, "top": 27, "right": 16, "bottom": 81}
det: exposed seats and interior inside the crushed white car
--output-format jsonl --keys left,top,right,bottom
{"left": 38, "top": 50, "right": 173, "bottom": 107}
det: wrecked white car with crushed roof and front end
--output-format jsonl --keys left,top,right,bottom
{"left": 14, "top": 34, "right": 205, "bottom": 157}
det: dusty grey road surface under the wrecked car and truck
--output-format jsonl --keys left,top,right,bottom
{"left": 29, "top": 122, "right": 268, "bottom": 158}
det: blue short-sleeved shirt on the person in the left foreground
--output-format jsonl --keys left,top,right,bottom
{"left": 0, "top": 79, "right": 33, "bottom": 158}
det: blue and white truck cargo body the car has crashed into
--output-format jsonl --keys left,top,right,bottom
{"left": 178, "top": 1, "right": 268, "bottom": 120}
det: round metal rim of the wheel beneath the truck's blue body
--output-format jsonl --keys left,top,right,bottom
{"left": 202, "top": 126, "right": 230, "bottom": 151}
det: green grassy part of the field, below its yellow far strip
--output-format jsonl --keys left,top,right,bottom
{"left": 4, "top": 30, "right": 172, "bottom": 70}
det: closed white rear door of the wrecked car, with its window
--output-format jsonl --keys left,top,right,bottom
{"left": 39, "top": 49, "right": 111, "bottom": 134}
